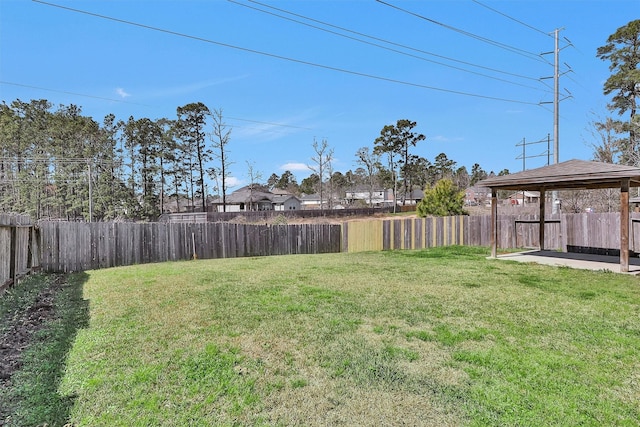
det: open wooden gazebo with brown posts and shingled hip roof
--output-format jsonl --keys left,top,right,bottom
{"left": 477, "top": 160, "right": 640, "bottom": 272}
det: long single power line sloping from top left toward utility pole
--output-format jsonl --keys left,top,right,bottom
{"left": 32, "top": 0, "right": 538, "bottom": 105}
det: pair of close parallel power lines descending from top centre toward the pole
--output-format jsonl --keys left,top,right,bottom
{"left": 232, "top": 0, "right": 540, "bottom": 90}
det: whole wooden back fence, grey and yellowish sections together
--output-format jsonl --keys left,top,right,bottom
{"left": 28, "top": 213, "right": 640, "bottom": 278}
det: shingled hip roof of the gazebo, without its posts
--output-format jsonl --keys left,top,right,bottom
{"left": 476, "top": 160, "right": 640, "bottom": 190}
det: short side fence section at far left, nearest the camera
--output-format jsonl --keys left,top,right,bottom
{"left": 0, "top": 214, "right": 40, "bottom": 290}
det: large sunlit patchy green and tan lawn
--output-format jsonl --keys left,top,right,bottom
{"left": 31, "top": 247, "right": 640, "bottom": 426}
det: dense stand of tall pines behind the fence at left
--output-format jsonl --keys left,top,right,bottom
{"left": 0, "top": 99, "right": 235, "bottom": 221}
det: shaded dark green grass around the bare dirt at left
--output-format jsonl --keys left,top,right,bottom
{"left": 0, "top": 274, "right": 88, "bottom": 427}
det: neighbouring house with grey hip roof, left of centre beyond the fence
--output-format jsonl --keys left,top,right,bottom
{"left": 212, "top": 185, "right": 301, "bottom": 212}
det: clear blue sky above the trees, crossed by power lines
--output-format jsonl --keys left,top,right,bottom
{"left": 0, "top": 0, "right": 640, "bottom": 189}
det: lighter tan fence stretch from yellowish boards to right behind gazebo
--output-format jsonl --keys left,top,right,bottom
{"left": 343, "top": 213, "right": 640, "bottom": 253}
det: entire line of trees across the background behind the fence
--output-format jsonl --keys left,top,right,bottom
{"left": 0, "top": 20, "right": 640, "bottom": 221}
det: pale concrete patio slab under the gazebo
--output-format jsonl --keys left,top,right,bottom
{"left": 498, "top": 250, "right": 640, "bottom": 276}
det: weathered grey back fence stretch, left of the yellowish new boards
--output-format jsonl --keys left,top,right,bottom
{"left": 40, "top": 222, "right": 340, "bottom": 272}
